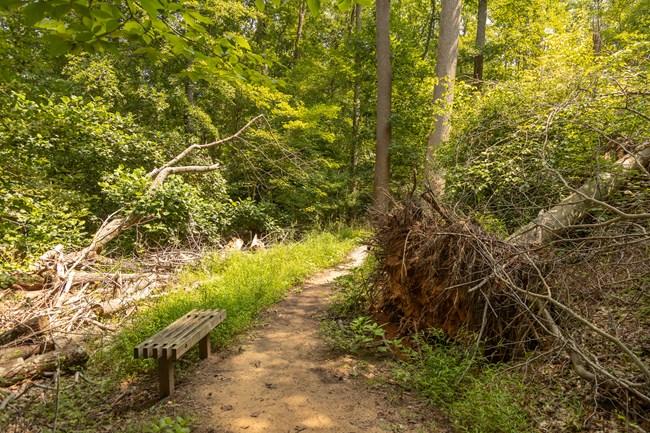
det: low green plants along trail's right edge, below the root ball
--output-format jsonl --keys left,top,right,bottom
{"left": 321, "top": 256, "right": 534, "bottom": 433}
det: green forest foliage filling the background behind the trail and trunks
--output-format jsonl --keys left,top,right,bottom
{"left": 0, "top": 0, "right": 650, "bottom": 268}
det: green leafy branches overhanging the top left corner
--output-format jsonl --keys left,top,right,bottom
{"left": 3, "top": 0, "right": 272, "bottom": 83}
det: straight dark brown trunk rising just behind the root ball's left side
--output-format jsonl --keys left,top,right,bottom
{"left": 374, "top": 0, "right": 392, "bottom": 211}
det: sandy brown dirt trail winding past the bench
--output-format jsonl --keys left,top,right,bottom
{"left": 176, "top": 249, "right": 442, "bottom": 433}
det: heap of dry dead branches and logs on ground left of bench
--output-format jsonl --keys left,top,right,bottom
{"left": 0, "top": 252, "right": 189, "bottom": 386}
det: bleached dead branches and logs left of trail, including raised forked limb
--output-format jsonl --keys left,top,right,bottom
{"left": 0, "top": 115, "right": 264, "bottom": 386}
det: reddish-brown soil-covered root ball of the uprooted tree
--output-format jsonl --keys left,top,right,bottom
{"left": 373, "top": 199, "right": 539, "bottom": 356}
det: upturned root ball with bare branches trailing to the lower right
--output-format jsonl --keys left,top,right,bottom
{"left": 373, "top": 193, "right": 650, "bottom": 408}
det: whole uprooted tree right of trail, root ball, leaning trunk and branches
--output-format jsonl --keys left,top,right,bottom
{"left": 372, "top": 148, "right": 650, "bottom": 408}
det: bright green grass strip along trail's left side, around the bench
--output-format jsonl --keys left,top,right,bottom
{"left": 0, "top": 229, "right": 362, "bottom": 432}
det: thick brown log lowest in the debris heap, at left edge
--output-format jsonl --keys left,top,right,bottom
{"left": 0, "top": 339, "right": 88, "bottom": 386}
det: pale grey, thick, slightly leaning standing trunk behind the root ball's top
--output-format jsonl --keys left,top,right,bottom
{"left": 424, "top": 0, "right": 462, "bottom": 194}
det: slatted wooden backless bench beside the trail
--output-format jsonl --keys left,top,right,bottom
{"left": 133, "top": 310, "right": 226, "bottom": 398}
